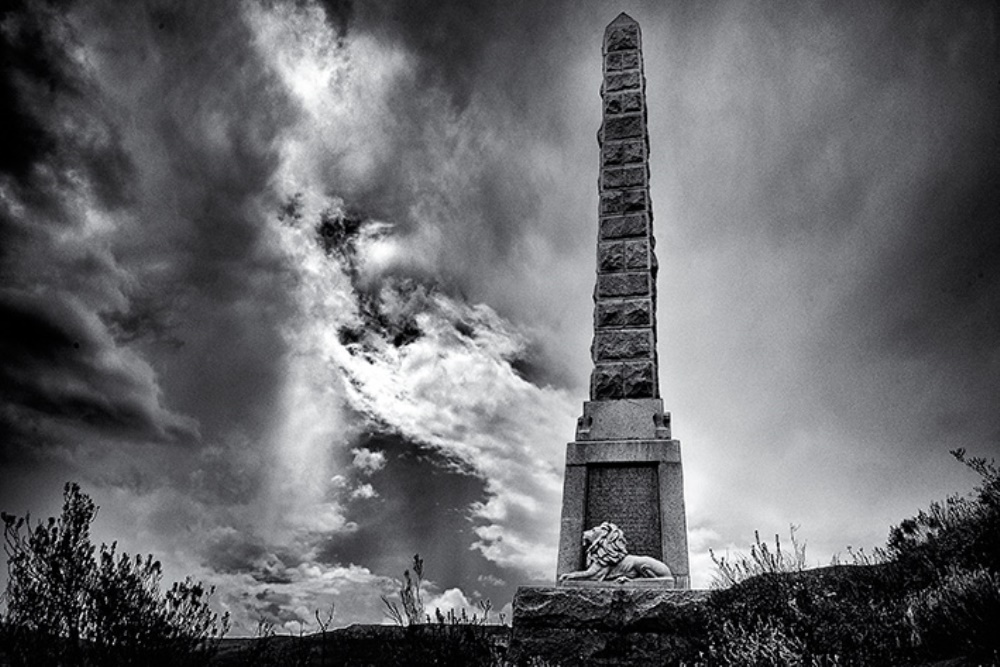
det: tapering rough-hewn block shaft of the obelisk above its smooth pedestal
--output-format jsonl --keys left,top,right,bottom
{"left": 590, "top": 17, "right": 659, "bottom": 401}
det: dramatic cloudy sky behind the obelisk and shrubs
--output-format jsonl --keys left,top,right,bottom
{"left": 0, "top": 0, "right": 1000, "bottom": 635}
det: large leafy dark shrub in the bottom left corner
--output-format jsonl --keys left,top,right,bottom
{"left": 2, "top": 484, "right": 229, "bottom": 665}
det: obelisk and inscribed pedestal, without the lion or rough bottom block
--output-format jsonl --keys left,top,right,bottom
{"left": 557, "top": 13, "right": 690, "bottom": 588}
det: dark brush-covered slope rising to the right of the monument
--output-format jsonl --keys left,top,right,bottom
{"left": 682, "top": 450, "right": 1000, "bottom": 666}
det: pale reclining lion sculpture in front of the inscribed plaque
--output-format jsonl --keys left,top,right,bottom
{"left": 559, "top": 521, "right": 673, "bottom": 583}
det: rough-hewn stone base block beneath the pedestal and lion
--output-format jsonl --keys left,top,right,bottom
{"left": 508, "top": 582, "right": 708, "bottom": 667}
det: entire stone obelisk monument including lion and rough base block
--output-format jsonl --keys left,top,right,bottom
{"left": 509, "top": 14, "right": 706, "bottom": 665}
